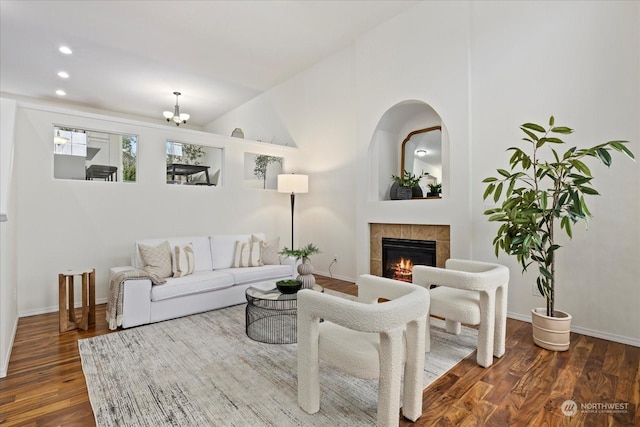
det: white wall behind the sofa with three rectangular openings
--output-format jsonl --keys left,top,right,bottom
{"left": 11, "top": 102, "right": 296, "bottom": 318}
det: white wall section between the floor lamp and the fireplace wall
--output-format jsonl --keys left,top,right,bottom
{"left": 206, "top": 48, "right": 362, "bottom": 280}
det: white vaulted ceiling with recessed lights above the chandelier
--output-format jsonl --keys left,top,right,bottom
{"left": 0, "top": 0, "right": 417, "bottom": 126}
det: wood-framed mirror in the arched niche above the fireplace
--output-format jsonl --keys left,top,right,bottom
{"left": 392, "top": 126, "right": 442, "bottom": 198}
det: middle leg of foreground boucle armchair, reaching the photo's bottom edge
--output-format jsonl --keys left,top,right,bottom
{"left": 377, "top": 328, "right": 404, "bottom": 427}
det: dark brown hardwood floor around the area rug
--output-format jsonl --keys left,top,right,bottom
{"left": 0, "top": 276, "right": 640, "bottom": 427}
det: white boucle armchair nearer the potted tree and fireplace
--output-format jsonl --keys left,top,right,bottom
{"left": 413, "top": 259, "right": 509, "bottom": 368}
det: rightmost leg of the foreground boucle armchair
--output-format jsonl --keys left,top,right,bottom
{"left": 402, "top": 317, "right": 427, "bottom": 421}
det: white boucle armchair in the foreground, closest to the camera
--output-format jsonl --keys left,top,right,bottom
{"left": 298, "top": 275, "right": 429, "bottom": 426}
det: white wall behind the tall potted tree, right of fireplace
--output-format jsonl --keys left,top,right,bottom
{"left": 471, "top": 1, "right": 640, "bottom": 345}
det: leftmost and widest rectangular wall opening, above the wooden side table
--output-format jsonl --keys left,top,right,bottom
{"left": 53, "top": 125, "right": 138, "bottom": 182}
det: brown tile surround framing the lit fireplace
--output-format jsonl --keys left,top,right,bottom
{"left": 369, "top": 223, "right": 450, "bottom": 276}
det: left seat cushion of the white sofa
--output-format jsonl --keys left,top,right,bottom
{"left": 151, "top": 271, "right": 234, "bottom": 301}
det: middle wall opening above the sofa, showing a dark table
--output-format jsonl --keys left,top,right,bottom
{"left": 166, "top": 141, "right": 223, "bottom": 186}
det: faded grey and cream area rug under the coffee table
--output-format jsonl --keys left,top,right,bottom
{"left": 78, "top": 304, "right": 477, "bottom": 427}
